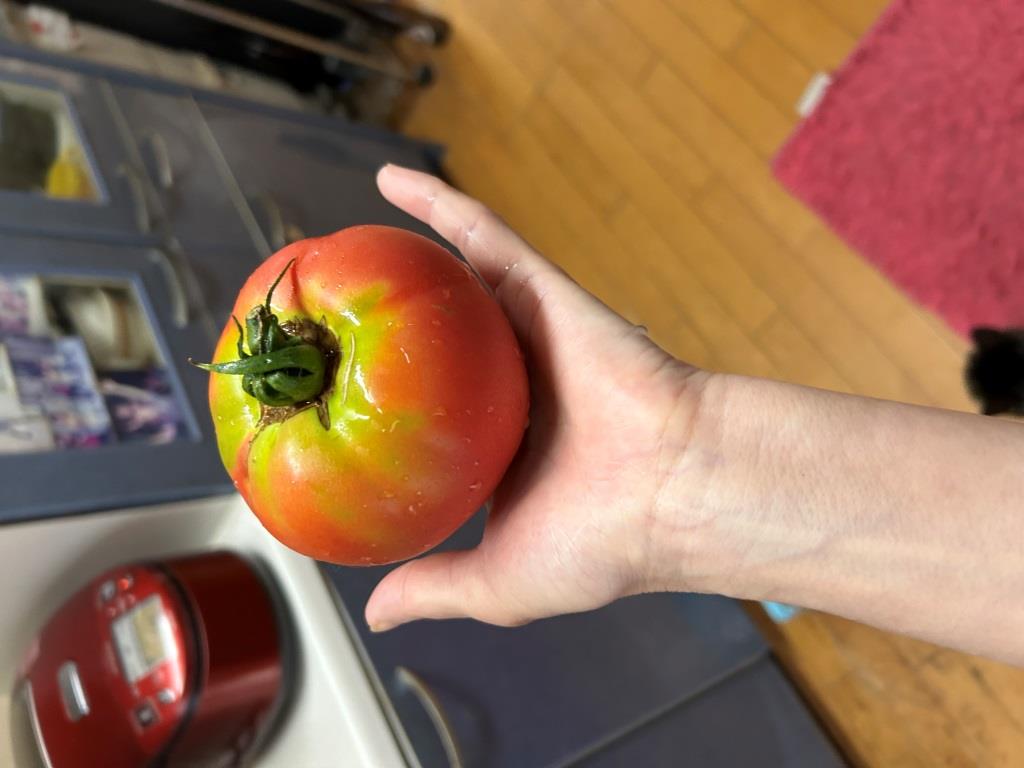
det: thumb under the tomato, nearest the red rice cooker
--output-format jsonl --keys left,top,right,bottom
{"left": 366, "top": 550, "right": 520, "bottom": 632}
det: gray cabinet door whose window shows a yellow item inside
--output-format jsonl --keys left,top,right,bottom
{"left": 0, "top": 56, "right": 152, "bottom": 239}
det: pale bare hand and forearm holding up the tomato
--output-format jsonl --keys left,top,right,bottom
{"left": 366, "top": 166, "right": 1024, "bottom": 665}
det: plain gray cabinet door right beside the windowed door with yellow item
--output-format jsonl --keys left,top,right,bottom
{"left": 112, "top": 85, "right": 261, "bottom": 259}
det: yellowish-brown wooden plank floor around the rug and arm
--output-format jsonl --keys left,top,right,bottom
{"left": 404, "top": 0, "right": 1024, "bottom": 768}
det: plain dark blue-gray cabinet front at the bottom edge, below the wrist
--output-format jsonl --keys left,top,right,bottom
{"left": 574, "top": 658, "right": 845, "bottom": 768}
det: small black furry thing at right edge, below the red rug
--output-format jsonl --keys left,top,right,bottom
{"left": 966, "top": 328, "right": 1024, "bottom": 416}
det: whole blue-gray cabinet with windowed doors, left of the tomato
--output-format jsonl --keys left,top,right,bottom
{"left": 0, "top": 45, "right": 444, "bottom": 522}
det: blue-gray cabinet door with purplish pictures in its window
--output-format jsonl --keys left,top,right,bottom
{"left": 0, "top": 234, "right": 231, "bottom": 523}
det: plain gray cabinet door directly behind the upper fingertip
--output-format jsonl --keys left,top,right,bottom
{"left": 200, "top": 100, "right": 442, "bottom": 251}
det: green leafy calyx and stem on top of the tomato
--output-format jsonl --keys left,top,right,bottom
{"left": 188, "top": 259, "right": 338, "bottom": 427}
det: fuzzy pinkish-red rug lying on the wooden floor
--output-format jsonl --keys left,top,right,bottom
{"left": 775, "top": 0, "right": 1024, "bottom": 333}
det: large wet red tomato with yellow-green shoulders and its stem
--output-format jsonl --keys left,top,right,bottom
{"left": 197, "top": 226, "right": 528, "bottom": 564}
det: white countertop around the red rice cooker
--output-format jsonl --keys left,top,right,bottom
{"left": 0, "top": 496, "right": 407, "bottom": 768}
